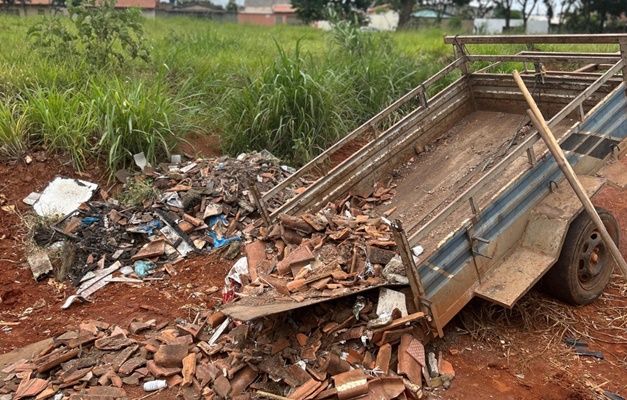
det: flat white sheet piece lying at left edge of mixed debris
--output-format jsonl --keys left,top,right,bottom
{"left": 33, "top": 177, "right": 98, "bottom": 217}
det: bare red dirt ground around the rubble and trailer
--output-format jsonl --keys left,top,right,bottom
{"left": 0, "top": 153, "right": 627, "bottom": 400}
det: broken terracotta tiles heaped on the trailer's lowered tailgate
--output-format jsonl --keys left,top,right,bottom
{"left": 224, "top": 180, "right": 408, "bottom": 312}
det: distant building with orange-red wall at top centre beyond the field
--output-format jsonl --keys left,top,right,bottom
{"left": 237, "top": 0, "right": 300, "bottom": 26}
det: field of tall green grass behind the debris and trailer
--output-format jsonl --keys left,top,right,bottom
{"left": 0, "top": 15, "right": 611, "bottom": 172}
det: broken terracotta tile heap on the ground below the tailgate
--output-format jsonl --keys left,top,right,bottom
{"left": 0, "top": 289, "right": 454, "bottom": 400}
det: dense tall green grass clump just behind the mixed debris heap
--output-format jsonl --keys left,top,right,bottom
{"left": 222, "top": 44, "right": 345, "bottom": 165}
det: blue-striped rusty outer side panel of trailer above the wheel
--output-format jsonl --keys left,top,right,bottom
{"left": 422, "top": 83, "right": 627, "bottom": 326}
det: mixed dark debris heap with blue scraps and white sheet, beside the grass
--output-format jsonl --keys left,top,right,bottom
{"left": 25, "top": 152, "right": 303, "bottom": 296}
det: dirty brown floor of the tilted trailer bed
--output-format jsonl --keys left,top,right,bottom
{"left": 377, "top": 111, "right": 573, "bottom": 250}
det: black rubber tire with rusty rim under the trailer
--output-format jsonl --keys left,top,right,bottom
{"left": 542, "top": 207, "right": 620, "bottom": 305}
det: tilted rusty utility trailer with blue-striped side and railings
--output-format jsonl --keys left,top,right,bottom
{"left": 223, "top": 34, "right": 627, "bottom": 337}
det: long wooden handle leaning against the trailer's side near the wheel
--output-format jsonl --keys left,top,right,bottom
{"left": 513, "top": 71, "right": 627, "bottom": 279}
